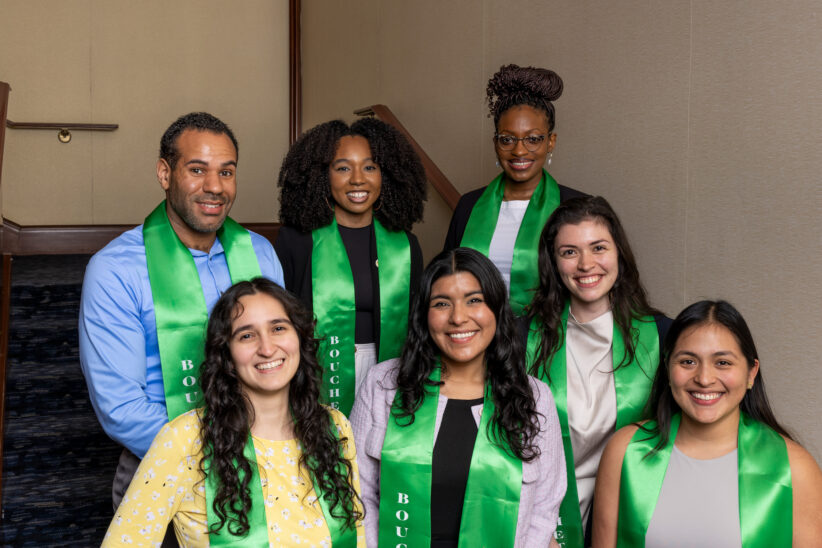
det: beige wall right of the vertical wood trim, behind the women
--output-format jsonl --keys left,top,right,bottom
{"left": 302, "top": 0, "right": 822, "bottom": 458}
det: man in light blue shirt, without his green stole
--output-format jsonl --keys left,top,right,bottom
{"left": 79, "top": 112, "right": 283, "bottom": 507}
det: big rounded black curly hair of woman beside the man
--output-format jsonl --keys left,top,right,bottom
{"left": 277, "top": 118, "right": 428, "bottom": 232}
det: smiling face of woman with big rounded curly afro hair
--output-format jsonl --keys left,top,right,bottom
{"left": 328, "top": 135, "right": 382, "bottom": 228}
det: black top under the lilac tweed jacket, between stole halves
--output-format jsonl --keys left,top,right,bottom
{"left": 431, "top": 398, "right": 483, "bottom": 548}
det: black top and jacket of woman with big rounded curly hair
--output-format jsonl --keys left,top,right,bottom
{"left": 274, "top": 226, "right": 422, "bottom": 351}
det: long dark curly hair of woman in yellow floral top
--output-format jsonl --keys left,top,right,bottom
{"left": 200, "top": 278, "right": 362, "bottom": 536}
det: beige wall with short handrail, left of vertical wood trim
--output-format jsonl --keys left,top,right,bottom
{"left": 0, "top": 0, "right": 288, "bottom": 225}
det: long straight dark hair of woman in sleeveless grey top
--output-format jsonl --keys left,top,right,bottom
{"left": 640, "top": 301, "right": 793, "bottom": 453}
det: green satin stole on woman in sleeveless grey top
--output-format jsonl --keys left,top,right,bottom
{"left": 617, "top": 413, "right": 793, "bottom": 548}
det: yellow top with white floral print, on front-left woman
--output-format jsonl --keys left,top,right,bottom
{"left": 103, "top": 409, "right": 365, "bottom": 548}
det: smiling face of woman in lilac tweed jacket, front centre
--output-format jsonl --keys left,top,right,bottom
{"left": 428, "top": 272, "right": 497, "bottom": 374}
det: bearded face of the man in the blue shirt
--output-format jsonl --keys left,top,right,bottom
{"left": 157, "top": 129, "right": 237, "bottom": 251}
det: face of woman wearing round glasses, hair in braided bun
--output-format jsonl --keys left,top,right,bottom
{"left": 494, "top": 105, "right": 557, "bottom": 190}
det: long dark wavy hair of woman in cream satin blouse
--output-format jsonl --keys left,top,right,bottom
{"left": 527, "top": 196, "right": 661, "bottom": 379}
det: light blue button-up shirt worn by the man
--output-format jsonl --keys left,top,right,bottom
{"left": 79, "top": 225, "right": 283, "bottom": 458}
